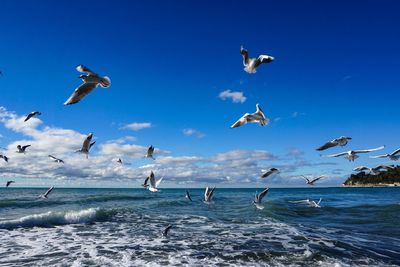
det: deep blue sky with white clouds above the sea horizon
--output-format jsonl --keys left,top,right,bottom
{"left": 0, "top": 0, "right": 400, "bottom": 187}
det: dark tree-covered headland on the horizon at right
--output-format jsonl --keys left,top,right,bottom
{"left": 343, "top": 166, "right": 400, "bottom": 187}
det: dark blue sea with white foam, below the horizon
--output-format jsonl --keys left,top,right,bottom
{"left": 0, "top": 187, "right": 400, "bottom": 267}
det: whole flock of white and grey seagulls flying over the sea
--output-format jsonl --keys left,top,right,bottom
{"left": 0, "top": 47, "right": 400, "bottom": 239}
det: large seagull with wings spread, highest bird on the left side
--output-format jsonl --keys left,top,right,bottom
{"left": 64, "top": 65, "right": 111, "bottom": 105}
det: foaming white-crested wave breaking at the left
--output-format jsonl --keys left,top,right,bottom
{"left": 0, "top": 208, "right": 115, "bottom": 229}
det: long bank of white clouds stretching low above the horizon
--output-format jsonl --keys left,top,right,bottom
{"left": 0, "top": 107, "right": 343, "bottom": 187}
